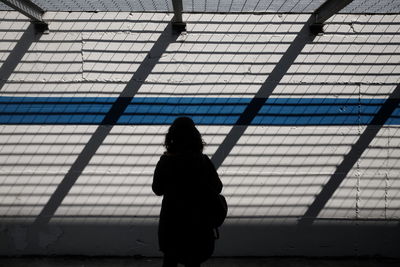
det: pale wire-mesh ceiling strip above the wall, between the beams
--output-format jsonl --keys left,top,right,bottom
{"left": 0, "top": 0, "right": 400, "bottom": 14}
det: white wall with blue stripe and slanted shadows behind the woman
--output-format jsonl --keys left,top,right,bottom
{"left": 0, "top": 11, "right": 400, "bottom": 256}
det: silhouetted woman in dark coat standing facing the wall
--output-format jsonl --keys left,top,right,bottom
{"left": 152, "top": 117, "right": 222, "bottom": 267}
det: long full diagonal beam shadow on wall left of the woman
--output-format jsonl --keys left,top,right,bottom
{"left": 33, "top": 22, "right": 179, "bottom": 227}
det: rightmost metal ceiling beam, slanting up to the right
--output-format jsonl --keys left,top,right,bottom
{"left": 310, "top": 0, "right": 353, "bottom": 35}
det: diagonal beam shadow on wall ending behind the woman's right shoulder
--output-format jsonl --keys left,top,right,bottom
{"left": 211, "top": 15, "right": 315, "bottom": 169}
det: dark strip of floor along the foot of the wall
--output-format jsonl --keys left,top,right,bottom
{"left": 0, "top": 257, "right": 400, "bottom": 267}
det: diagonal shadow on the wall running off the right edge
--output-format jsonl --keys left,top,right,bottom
{"left": 298, "top": 85, "right": 400, "bottom": 226}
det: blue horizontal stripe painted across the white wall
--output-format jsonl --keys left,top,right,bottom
{"left": 0, "top": 97, "right": 400, "bottom": 125}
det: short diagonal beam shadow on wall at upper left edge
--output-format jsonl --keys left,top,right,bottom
{"left": 0, "top": 23, "right": 42, "bottom": 90}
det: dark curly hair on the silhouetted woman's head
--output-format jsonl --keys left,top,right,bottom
{"left": 164, "top": 117, "right": 204, "bottom": 154}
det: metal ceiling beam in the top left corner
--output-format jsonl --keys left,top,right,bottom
{"left": 0, "top": 0, "right": 48, "bottom": 32}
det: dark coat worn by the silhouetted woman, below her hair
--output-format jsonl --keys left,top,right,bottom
{"left": 152, "top": 154, "right": 222, "bottom": 262}
